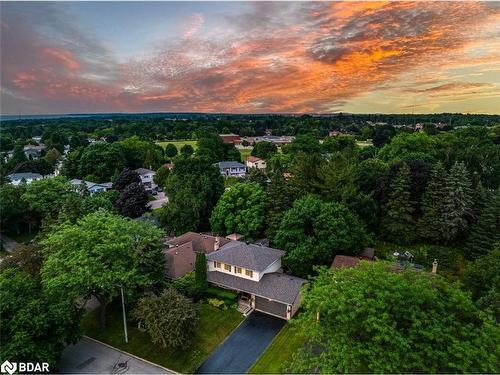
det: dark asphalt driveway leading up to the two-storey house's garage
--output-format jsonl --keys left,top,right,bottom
{"left": 196, "top": 312, "right": 285, "bottom": 374}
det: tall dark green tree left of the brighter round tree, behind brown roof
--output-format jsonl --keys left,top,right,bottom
{"left": 161, "top": 157, "right": 224, "bottom": 234}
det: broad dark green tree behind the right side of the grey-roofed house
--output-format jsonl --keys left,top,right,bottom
{"left": 273, "top": 195, "right": 369, "bottom": 277}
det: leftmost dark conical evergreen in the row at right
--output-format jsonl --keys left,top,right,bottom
{"left": 382, "top": 163, "right": 415, "bottom": 244}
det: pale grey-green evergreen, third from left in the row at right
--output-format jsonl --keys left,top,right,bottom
{"left": 442, "top": 163, "right": 473, "bottom": 242}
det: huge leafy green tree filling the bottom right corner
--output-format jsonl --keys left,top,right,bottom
{"left": 290, "top": 262, "right": 500, "bottom": 373}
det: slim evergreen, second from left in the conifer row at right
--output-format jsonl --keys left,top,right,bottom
{"left": 418, "top": 163, "right": 447, "bottom": 242}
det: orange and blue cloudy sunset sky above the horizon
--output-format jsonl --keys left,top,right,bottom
{"left": 0, "top": 2, "right": 500, "bottom": 115}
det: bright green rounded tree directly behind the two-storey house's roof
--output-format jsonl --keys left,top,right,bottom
{"left": 210, "top": 182, "right": 266, "bottom": 238}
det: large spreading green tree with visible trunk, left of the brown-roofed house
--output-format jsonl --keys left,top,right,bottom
{"left": 41, "top": 211, "right": 165, "bottom": 327}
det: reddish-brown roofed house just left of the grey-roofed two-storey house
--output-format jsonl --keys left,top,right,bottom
{"left": 163, "top": 232, "right": 230, "bottom": 279}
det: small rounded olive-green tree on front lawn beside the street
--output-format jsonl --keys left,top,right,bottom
{"left": 132, "top": 288, "right": 198, "bottom": 349}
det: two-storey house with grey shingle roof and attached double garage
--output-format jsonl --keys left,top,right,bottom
{"left": 207, "top": 241, "right": 306, "bottom": 320}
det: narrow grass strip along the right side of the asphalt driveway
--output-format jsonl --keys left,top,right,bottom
{"left": 248, "top": 323, "right": 306, "bottom": 374}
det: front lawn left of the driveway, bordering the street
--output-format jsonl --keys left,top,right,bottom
{"left": 82, "top": 304, "right": 243, "bottom": 373}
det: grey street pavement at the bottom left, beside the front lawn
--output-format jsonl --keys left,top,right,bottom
{"left": 58, "top": 337, "right": 174, "bottom": 374}
